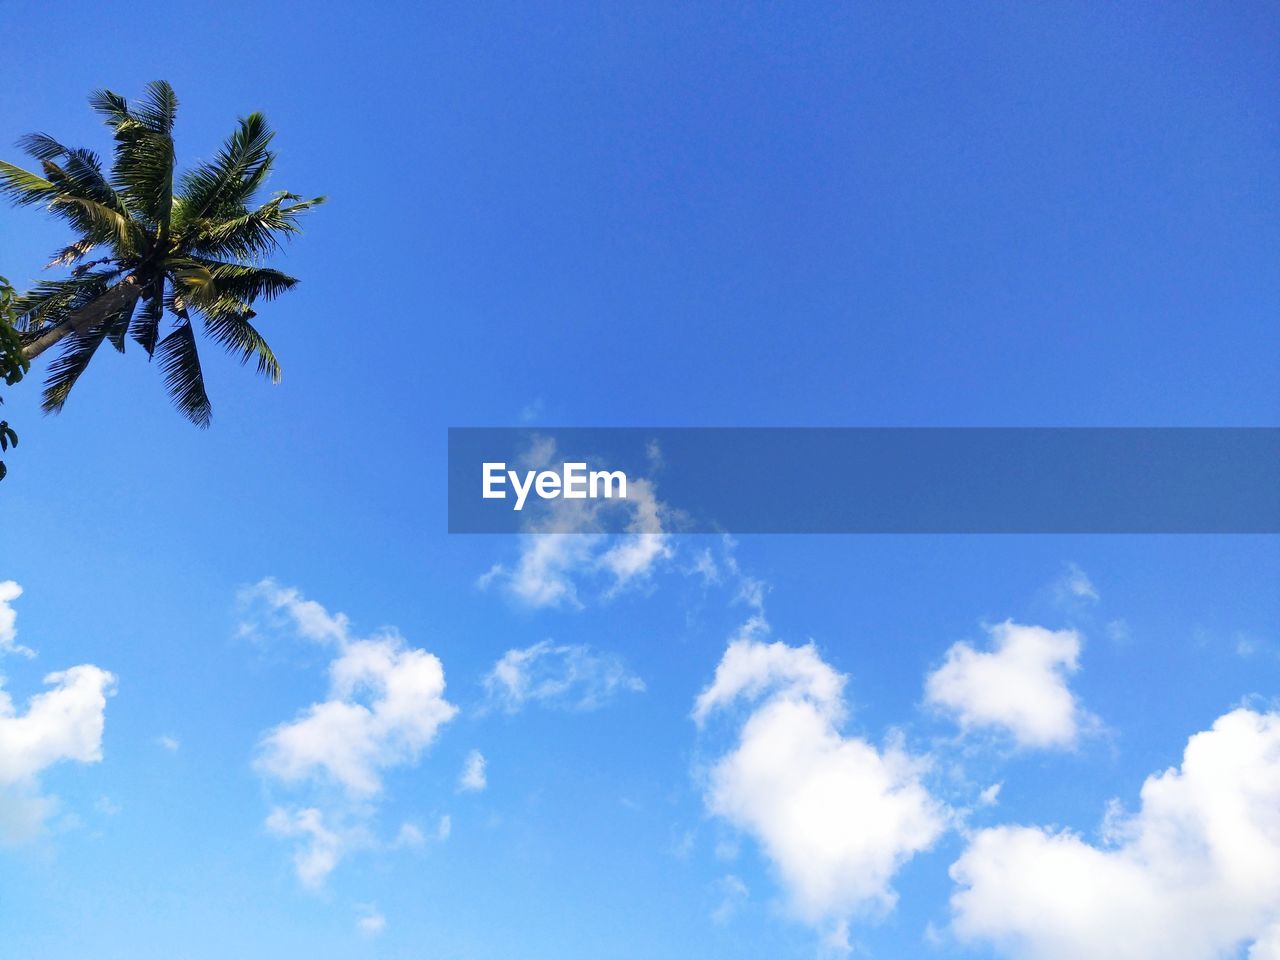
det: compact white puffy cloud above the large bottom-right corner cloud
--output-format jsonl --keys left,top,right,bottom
{"left": 924, "top": 621, "right": 1094, "bottom": 748}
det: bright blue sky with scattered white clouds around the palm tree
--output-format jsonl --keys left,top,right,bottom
{"left": 0, "top": 3, "right": 1280, "bottom": 960}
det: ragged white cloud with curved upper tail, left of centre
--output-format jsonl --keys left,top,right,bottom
{"left": 242, "top": 580, "right": 457, "bottom": 886}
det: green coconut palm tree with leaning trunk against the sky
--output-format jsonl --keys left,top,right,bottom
{"left": 0, "top": 81, "right": 324, "bottom": 426}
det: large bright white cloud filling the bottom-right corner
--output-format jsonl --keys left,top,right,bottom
{"left": 951, "top": 708, "right": 1280, "bottom": 960}
